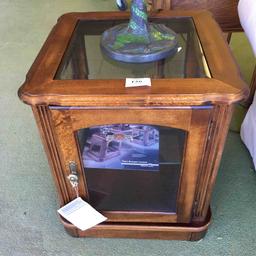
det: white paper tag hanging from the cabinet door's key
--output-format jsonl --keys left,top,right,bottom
{"left": 58, "top": 197, "right": 107, "bottom": 230}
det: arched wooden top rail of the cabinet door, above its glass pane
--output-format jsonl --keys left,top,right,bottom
{"left": 65, "top": 108, "right": 191, "bottom": 131}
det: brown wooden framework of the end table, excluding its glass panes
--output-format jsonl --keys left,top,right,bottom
{"left": 18, "top": 11, "right": 248, "bottom": 240}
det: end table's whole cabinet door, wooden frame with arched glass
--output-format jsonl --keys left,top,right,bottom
{"left": 50, "top": 106, "right": 212, "bottom": 223}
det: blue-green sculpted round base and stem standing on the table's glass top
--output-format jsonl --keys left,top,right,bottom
{"left": 101, "top": 0, "right": 177, "bottom": 63}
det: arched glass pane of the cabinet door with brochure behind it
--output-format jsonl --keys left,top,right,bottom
{"left": 77, "top": 124, "right": 186, "bottom": 213}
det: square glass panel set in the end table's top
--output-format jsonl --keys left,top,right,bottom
{"left": 55, "top": 17, "right": 210, "bottom": 80}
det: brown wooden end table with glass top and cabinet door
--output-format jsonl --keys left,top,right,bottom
{"left": 19, "top": 11, "right": 248, "bottom": 240}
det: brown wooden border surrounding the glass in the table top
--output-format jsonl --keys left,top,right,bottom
{"left": 19, "top": 11, "right": 248, "bottom": 106}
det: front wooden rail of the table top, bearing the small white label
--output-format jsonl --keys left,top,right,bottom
{"left": 20, "top": 78, "right": 248, "bottom": 107}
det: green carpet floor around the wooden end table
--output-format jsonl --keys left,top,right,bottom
{"left": 0, "top": 0, "right": 256, "bottom": 256}
